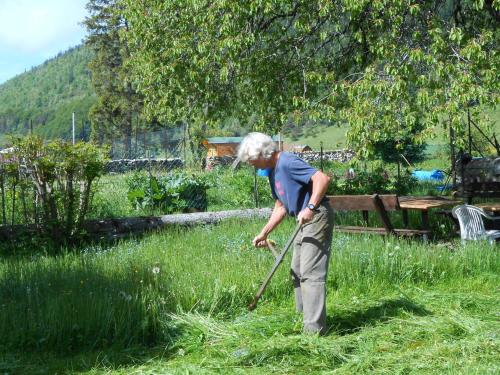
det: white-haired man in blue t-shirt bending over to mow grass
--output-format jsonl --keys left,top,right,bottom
{"left": 235, "top": 133, "right": 333, "bottom": 334}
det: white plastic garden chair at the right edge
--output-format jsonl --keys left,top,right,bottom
{"left": 451, "top": 204, "right": 500, "bottom": 245}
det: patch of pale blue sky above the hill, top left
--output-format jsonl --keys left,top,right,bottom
{"left": 0, "top": 0, "right": 87, "bottom": 84}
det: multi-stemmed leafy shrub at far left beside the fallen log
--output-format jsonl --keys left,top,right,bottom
{"left": 7, "top": 136, "right": 107, "bottom": 243}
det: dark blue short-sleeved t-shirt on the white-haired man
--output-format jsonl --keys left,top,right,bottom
{"left": 269, "top": 152, "right": 318, "bottom": 216}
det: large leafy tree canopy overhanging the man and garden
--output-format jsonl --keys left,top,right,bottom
{"left": 121, "top": 0, "right": 500, "bottom": 156}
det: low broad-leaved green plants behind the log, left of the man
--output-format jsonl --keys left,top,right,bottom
{"left": 126, "top": 171, "right": 209, "bottom": 214}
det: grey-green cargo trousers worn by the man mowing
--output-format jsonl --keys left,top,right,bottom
{"left": 291, "top": 201, "right": 333, "bottom": 334}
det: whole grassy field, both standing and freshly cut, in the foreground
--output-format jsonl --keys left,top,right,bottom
{"left": 0, "top": 221, "right": 500, "bottom": 374}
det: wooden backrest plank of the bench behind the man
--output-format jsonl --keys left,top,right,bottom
{"left": 327, "top": 194, "right": 399, "bottom": 211}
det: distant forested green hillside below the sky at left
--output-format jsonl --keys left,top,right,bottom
{"left": 0, "top": 46, "right": 96, "bottom": 143}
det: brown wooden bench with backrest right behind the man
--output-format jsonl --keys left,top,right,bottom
{"left": 327, "top": 194, "right": 429, "bottom": 240}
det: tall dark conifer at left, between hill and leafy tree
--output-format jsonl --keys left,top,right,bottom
{"left": 84, "top": 0, "right": 142, "bottom": 156}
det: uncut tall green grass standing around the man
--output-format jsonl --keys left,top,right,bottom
{"left": 0, "top": 217, "right": 500, "bottom": 351}
